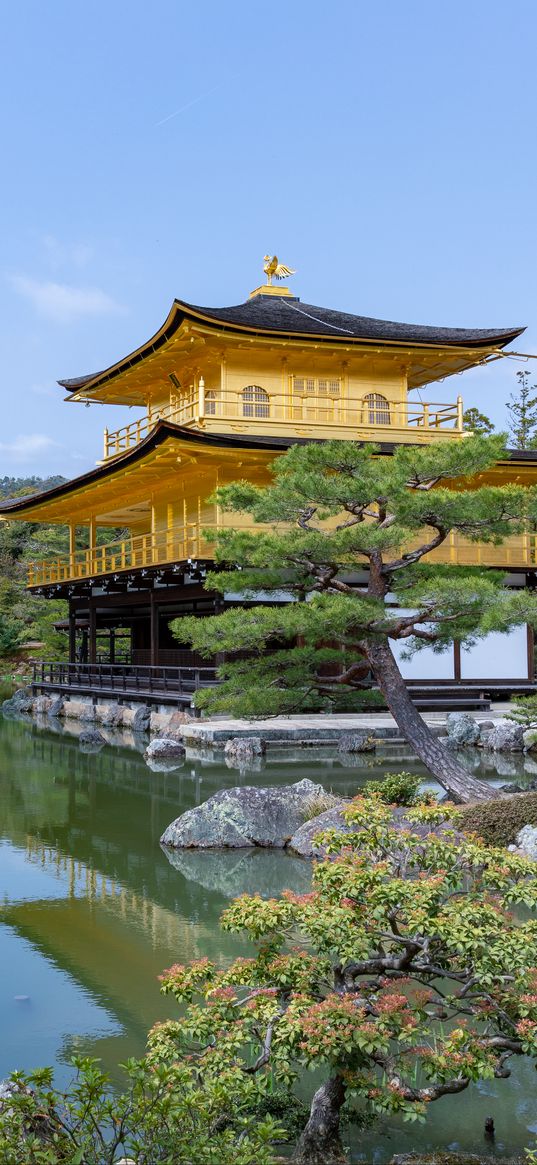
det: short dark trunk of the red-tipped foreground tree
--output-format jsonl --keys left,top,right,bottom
{"left": 292, "top": 1075, "right": 347, "bottom": 1165}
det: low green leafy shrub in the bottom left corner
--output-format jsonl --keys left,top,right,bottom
{"left": 0, "top": 1055, "right": 283, "bottom": 1165}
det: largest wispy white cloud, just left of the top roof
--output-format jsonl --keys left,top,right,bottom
{"left": 10, "top": 275, "right": 126, "bottom": 324}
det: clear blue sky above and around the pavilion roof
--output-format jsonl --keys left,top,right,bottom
{"left": 0, "top": 0, "right": 537, "bottom": 476}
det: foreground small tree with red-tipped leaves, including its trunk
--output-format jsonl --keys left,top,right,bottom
{"left": 158, "top": 796, "right": 537, "bottom": 1163}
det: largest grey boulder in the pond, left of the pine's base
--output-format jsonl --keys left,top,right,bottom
{"left": 161, "top": 779, "right": 337, "bottom": 849}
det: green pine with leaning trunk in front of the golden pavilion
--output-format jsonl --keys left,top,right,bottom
{"left": 172, "top": 436, "right": 537, "bottom": 800}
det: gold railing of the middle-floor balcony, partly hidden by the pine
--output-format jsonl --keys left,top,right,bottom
{"left": 28, "top": 522, "right": 537, "bottom": 587}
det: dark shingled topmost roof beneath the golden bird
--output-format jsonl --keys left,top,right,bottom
{"left": 58, "top": 294, "right": 524, "bottom": 393}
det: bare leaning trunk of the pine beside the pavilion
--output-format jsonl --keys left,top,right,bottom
{"left": 365, "top": 643, "right": 501, "bottom": 804}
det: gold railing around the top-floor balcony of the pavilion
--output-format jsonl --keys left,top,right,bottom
{"left": 104, "top": 393, "right": 464, "bottom": 460}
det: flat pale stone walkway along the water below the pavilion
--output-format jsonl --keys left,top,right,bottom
{"left": 182, "top": 701, "right": 509, "bottom": 748}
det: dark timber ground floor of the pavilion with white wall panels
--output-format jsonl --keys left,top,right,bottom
{"left": 27, "top": 564, "right": 536, "bottom": 707}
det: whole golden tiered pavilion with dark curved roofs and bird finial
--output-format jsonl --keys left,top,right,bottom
{"left": 0, "top": 256, "right": 537, "bottom": 701}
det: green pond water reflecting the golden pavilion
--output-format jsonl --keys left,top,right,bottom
{"left": 0, "top": 716, "right": 537, "bottom": 1165}
